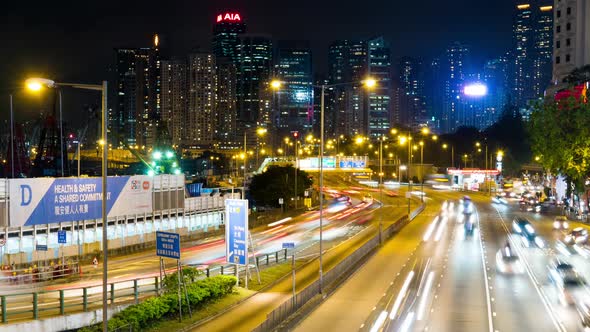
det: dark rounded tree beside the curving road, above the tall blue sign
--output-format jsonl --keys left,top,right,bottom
{"left": 250, "top": 165, "right": 313, "bottom": 207}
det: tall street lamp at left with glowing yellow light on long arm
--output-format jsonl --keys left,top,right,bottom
{"left": 26, "top": 78, "right": 109, "bottom": 332}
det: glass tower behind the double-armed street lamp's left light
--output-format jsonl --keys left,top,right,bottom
{"left": 275, "top": 41, "right": 314, "bottom": 135}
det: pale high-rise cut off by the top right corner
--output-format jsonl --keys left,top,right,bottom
{"left": 552, "top": 0, "right": 590, "bottom": 88}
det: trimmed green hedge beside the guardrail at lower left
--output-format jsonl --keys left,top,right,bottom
{"left": 79, "top": 275, "right": 237, "bottom": 332}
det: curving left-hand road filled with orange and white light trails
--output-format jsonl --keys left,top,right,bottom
{"left": 0, "top": 179, "right": 412, "bottom": 321}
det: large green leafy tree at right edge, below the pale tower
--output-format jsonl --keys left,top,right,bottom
{"left": 530, "top": 97, "right": 590, "bottom": 191}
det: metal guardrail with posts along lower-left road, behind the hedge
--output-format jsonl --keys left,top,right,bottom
{"left": 0, "top": 249, "right": 288, "bottom": 323}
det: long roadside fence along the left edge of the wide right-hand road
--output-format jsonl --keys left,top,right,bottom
{"left": 252, "top": 205, "right": 424, "bottom": 332}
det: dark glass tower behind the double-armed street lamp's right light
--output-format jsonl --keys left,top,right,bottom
{"left": 365, "top": 37, "right": 391, "bottom": 137}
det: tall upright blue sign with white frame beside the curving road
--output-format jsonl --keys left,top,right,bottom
{"left": 225, "top": 199, "right": 248, "bottom": 265}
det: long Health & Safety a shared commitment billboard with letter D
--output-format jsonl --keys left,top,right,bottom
{"left": 9, "top": 175, "right": 153, "bottom": 226}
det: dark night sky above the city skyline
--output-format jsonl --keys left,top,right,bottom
{"left": 0, "top": 0, "right": 513, "bottom": 126}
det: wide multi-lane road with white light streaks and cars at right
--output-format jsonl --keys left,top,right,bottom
{"left": 295, "top": 191, "right": 590, "bottom": 332}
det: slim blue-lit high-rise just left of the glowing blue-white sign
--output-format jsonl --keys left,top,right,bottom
{"left": 440, "top": 42, "right": 469, "bottom": 133}
